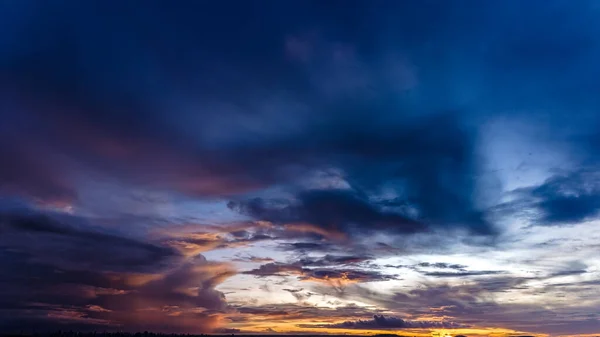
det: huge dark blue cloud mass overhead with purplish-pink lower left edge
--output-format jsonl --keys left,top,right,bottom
{"left": 2, "top": 2, "right": 493, "bottom": 234}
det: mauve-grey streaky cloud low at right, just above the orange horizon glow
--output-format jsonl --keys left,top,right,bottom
{"left": 318, "top": 273, "right": 598, "bottom": 333}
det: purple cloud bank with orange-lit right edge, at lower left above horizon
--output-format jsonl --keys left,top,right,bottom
{"left": 0, "top": 203, "right": 235, "bottom": 332}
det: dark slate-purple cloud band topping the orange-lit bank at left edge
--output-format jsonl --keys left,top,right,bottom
{"left": 0, "top": 205, "right": 179, "bottom": 272}
